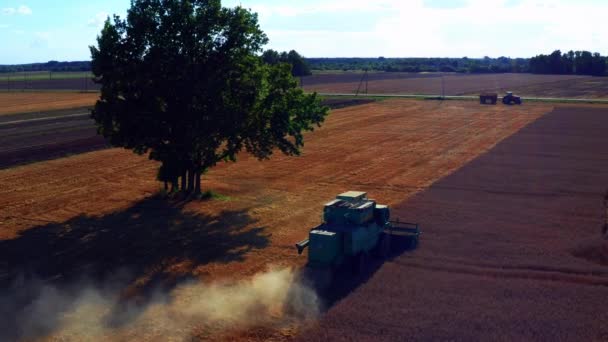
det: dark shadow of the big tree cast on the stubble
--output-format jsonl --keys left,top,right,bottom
{"left": 0, "top": 197, "right": 269, "bottom": 339}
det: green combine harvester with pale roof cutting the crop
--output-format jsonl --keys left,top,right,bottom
{"left": 296, "top": 191, "right": 420, "bottom": 290}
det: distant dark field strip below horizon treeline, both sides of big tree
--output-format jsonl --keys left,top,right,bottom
{"left": 0, "top": 71, "right": 608, "bottom": 99}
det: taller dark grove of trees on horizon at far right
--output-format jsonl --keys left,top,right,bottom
{"left": 530, "top": 50, "right": 607, "bottom": 76}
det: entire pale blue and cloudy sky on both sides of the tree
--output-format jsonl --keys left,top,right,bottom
{"left": 0, "top": 0, "right": 608, "bottom": 64}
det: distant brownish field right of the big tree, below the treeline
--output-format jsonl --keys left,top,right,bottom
{"left": 303, "top": 73, "right": 608, "bottom": 98}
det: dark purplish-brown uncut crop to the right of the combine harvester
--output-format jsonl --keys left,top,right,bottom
{"left": 303, "top": 106, "right": 608, "bottom": 341}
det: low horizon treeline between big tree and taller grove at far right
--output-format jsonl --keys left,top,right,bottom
{"left": 306, "top": 57, "right": 529, "bottom": 73}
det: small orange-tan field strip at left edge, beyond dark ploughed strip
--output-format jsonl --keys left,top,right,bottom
{"left": 0, "top": 92, "right": 99, "bottom": 115}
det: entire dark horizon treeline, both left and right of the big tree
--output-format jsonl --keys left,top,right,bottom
{"left": 0, "top": 49, "right": 608, "bottom": 77}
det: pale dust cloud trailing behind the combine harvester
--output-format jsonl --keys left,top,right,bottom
{"left": 0, "top": 268, "right": 319, "bottom": 341}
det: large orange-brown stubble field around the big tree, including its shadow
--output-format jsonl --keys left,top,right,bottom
{"left": 0, "top": 100, "right": 553, "bottom": 339}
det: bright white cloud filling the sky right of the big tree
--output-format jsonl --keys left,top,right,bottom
{"left": 243, "top": 0, "right": 608, "bottom": 57}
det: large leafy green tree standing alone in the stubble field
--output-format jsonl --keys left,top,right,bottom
{"left": 90, "top": 0, "right": 328, "bottom": 193}
